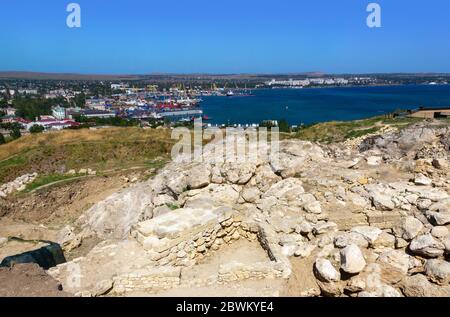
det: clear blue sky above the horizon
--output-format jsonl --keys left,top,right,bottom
{"left": 0, "top": 0, "right": 450, "bottom": 74}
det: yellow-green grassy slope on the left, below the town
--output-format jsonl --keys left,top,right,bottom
{"left": 0, "top": 128, "right": 175, "bottom": 183}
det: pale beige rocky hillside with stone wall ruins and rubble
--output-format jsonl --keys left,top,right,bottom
{"left": 44, "top": 123, "right": 450, "bottom": 297}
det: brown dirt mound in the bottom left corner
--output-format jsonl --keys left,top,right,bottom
{"left": 0, "top": 264, "right": 71, "bottom": 297}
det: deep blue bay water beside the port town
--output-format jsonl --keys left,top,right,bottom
{"left": 202, "top": 85, "right": 450, "bottom": 124}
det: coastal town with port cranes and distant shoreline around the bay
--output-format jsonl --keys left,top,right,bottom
{"left": 0, "top": 74, "right": 449, "bottom": 139}
